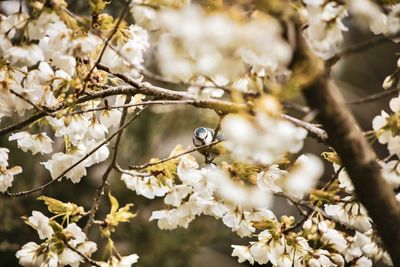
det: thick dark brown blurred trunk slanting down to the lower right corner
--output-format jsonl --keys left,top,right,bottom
{"left": 303, "top": 72, "right": 400, "bottom": 266}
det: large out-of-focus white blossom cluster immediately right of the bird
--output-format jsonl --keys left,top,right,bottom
{"left": 221, "top": 112, "right": 307, "bottom": 164}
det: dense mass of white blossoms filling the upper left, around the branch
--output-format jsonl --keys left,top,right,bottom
{"left": 0, "top": 4, "right": 148, "bottom": 187}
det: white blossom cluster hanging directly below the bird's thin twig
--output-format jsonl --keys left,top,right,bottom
{"left": 121, "top": 152, "right": 321, "bottom": 237}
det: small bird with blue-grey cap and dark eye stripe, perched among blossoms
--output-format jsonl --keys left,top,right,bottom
{"left": 193, "top": 127, "right": 226, "bottom": 163}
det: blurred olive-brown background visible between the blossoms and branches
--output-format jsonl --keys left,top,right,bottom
{"left": 0, "top": 0, "right": 399, "bottom": 267}
